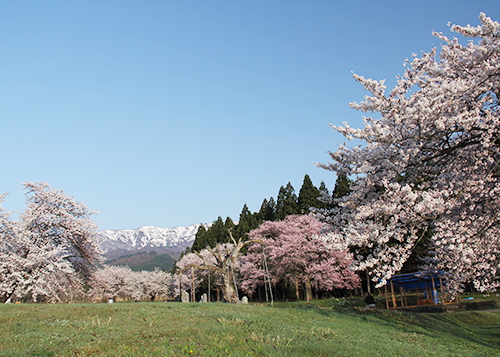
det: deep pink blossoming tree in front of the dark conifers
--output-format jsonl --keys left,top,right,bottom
{"left": 240, "top": 215, "right": 359, "bottom": 301}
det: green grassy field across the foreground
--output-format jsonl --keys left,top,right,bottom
{"left": 0, "top": 299, "right": 500, "bottom": 356}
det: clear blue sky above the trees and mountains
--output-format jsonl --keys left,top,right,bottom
{"left": 0, "top": 0, "right": 500, "bottom": 229}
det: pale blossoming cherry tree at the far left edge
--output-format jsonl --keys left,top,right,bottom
{"left": 0, "top": 182, "right": 101, "bottom": 302}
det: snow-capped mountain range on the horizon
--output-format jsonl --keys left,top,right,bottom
{"left": 98, "top": 224, "right": 208, "bottom": 255}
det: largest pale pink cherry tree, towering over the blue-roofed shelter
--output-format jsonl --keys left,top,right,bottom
{"left": 318, "top": 13, "right": 500, "bottom": 292}
